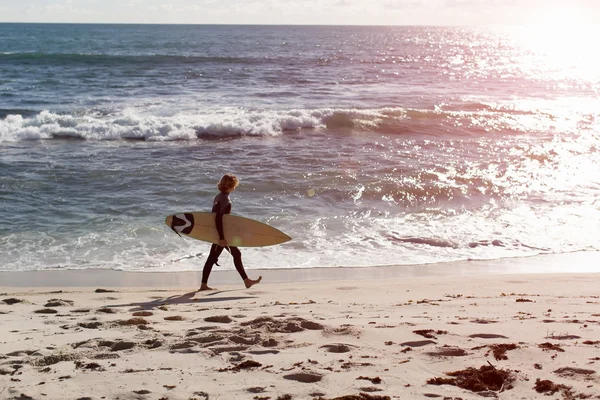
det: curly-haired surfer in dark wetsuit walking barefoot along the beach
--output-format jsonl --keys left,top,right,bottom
{"left": 200, "top": 174, "right": 262, "bottom": 290}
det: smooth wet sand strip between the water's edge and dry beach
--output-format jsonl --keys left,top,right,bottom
{"left": 0, "top": 252, "right": 600, "bottom": 288}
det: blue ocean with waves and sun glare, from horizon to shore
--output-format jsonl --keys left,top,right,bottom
{"left": 0, "top": 24, "right": 600, "bottom": 272}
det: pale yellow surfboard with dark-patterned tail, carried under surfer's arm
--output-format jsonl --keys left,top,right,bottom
{"left": 165, "top": 212, "right": 292, "bottom": 247}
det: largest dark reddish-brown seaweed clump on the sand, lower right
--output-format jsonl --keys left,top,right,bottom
{"left": 427, "top": 365, "right": 515, "bottom": 392}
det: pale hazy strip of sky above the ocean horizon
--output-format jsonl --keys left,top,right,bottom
{"left": 0, "top": 0, "right": 600, "bottom": 26}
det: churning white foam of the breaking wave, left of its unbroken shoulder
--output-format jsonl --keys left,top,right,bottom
{"left": 0, "top": 108, "right": 412, "bottom": 142}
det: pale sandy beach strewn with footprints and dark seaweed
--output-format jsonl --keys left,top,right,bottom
{"left": 0, "top": 255, "right": 600, "bottom": 400}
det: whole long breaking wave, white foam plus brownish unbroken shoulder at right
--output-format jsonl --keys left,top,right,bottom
{"left": 0, "top": 107, "right": 544, "bottom": 142}
